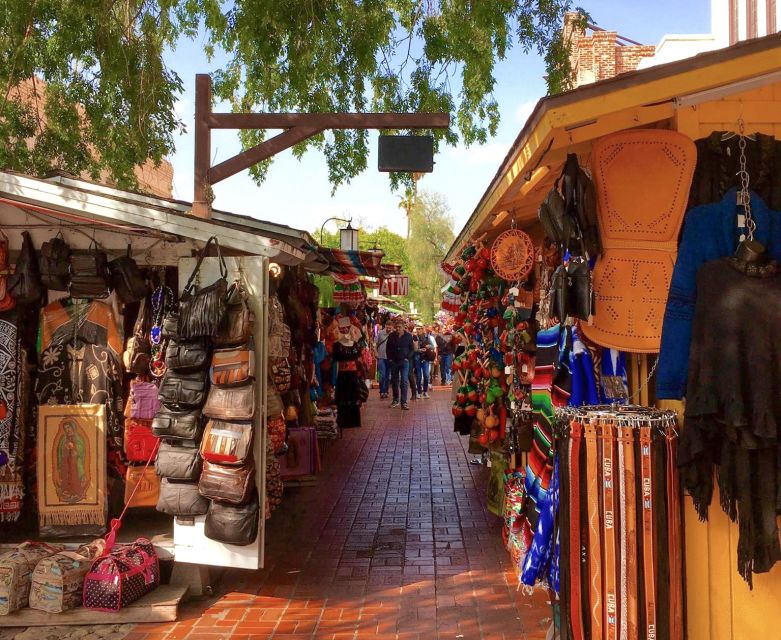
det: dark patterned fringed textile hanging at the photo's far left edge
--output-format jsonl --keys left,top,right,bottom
{"left": 0, "top": 313, "right": 26, "bottom": 522}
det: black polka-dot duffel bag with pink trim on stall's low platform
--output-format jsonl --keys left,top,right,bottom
{"left": 84, "top": 538, "right": 160, "bottom": 612}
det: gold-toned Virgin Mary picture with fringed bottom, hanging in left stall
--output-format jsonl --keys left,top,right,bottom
{"left": 37, "top": 404, "right": 106, "bottom": 529}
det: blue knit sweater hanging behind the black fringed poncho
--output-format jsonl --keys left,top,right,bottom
{"left": 656, "top": 189, "right": 781, "bottom": 400}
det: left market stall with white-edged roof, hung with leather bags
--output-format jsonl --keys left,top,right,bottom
{"left": 0, "top": 173, "right": 318, "bottom": 626}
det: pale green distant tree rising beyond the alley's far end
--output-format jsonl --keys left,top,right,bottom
{"left": 407, "top": 192, "right": 455, "bottom": 322}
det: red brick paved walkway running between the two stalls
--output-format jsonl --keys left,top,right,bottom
{"left": 127, "top": 391, "right": 550, "bottom": 640}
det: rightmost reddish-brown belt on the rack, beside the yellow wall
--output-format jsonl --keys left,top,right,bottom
{"left": 665, "top": 425, "right": 683, "bottom": 640}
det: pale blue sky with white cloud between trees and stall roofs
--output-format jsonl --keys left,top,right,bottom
{"left": 167, "top": 0, "right": 710, "bottom": 238}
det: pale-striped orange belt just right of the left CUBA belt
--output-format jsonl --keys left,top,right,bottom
{"left": 618, "top": 427, "right": 638, "bottom": 640}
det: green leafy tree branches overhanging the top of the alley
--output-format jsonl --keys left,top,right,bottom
{"left": 0, "top": 0, "right": 584, "bottom": 188}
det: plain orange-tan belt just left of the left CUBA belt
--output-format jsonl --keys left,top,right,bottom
{"left": 584, "top": 420, "right": 604, "bottom": 640}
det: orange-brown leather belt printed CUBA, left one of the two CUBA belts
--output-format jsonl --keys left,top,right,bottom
{"left": 602, "top": 423, "right": 618, "bottom": 640}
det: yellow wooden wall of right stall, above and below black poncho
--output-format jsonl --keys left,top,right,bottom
{"left": 660, "top": 77, "right": 781, "bottom": 640}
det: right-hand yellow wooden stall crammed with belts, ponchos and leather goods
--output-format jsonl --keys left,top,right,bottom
{"left": 443, "top": 35, "right": 781, "bottom": 640}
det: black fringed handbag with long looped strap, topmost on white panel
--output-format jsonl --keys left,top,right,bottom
{"left": 179, "top": 236, "right": 228, "bottom": 340}
